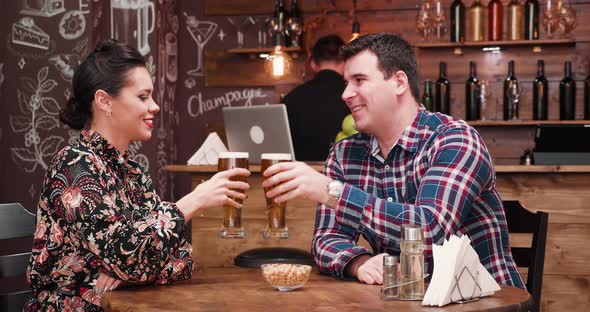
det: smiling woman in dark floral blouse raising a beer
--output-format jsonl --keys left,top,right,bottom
{"left": 26, "top": 40, "right": 249, "bottom": 311}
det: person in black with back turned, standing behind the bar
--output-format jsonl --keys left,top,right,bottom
{"left": 283, "top": 35, "right": 349, "bottom": 161}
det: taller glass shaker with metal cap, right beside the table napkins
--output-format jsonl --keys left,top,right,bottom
{"left": 400, "top": 224, "right": 424, "bottom": 300}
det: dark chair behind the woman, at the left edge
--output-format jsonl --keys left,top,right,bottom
{"left": 0, "top": 203, "right": 35, "bottom": 311}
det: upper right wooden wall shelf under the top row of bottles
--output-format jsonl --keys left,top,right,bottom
{"left": 415, "top": 39, "right": 576, "bottom": 54}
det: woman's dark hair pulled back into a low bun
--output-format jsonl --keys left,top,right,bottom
{"left": 59, "top": 39, "right": 145, "bottom": 130}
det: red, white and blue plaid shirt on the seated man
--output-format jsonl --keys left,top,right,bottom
{"left": 312, "top": 106, "right": 524, "bottom": 288}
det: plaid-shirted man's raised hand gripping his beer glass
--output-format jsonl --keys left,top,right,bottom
{"left": 262, "top": 162, "right": 332, "bottom": 203}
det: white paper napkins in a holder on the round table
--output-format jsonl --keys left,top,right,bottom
{"left": 422, "top": 235, "right": 500, "bottom": 307}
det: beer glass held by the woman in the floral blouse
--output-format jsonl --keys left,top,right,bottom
{"left": 217, "top": 152, "right": 249, "bottom": 238}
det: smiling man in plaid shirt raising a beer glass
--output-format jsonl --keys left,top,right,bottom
{"left": 263, "top": 33, "right": 524, "bottom": 288}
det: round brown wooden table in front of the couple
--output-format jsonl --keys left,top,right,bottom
{"left": 102, "top": 267, "right": 532, "bottom": 312}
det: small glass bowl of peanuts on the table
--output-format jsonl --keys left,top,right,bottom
{"left": 260, "top": 263, "right": 311, "bottom": 291}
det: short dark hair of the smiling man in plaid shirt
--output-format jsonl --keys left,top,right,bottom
{"left": 342, "top": 33, "right": 420, "bottom": 102}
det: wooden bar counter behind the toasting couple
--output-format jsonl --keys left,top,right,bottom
{"left": 166, "top": 163, "right": 590, "bottom": 311}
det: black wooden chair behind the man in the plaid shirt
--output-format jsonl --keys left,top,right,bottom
{"left": 503, "top": 200, "right": 549, "bottom": 311}
